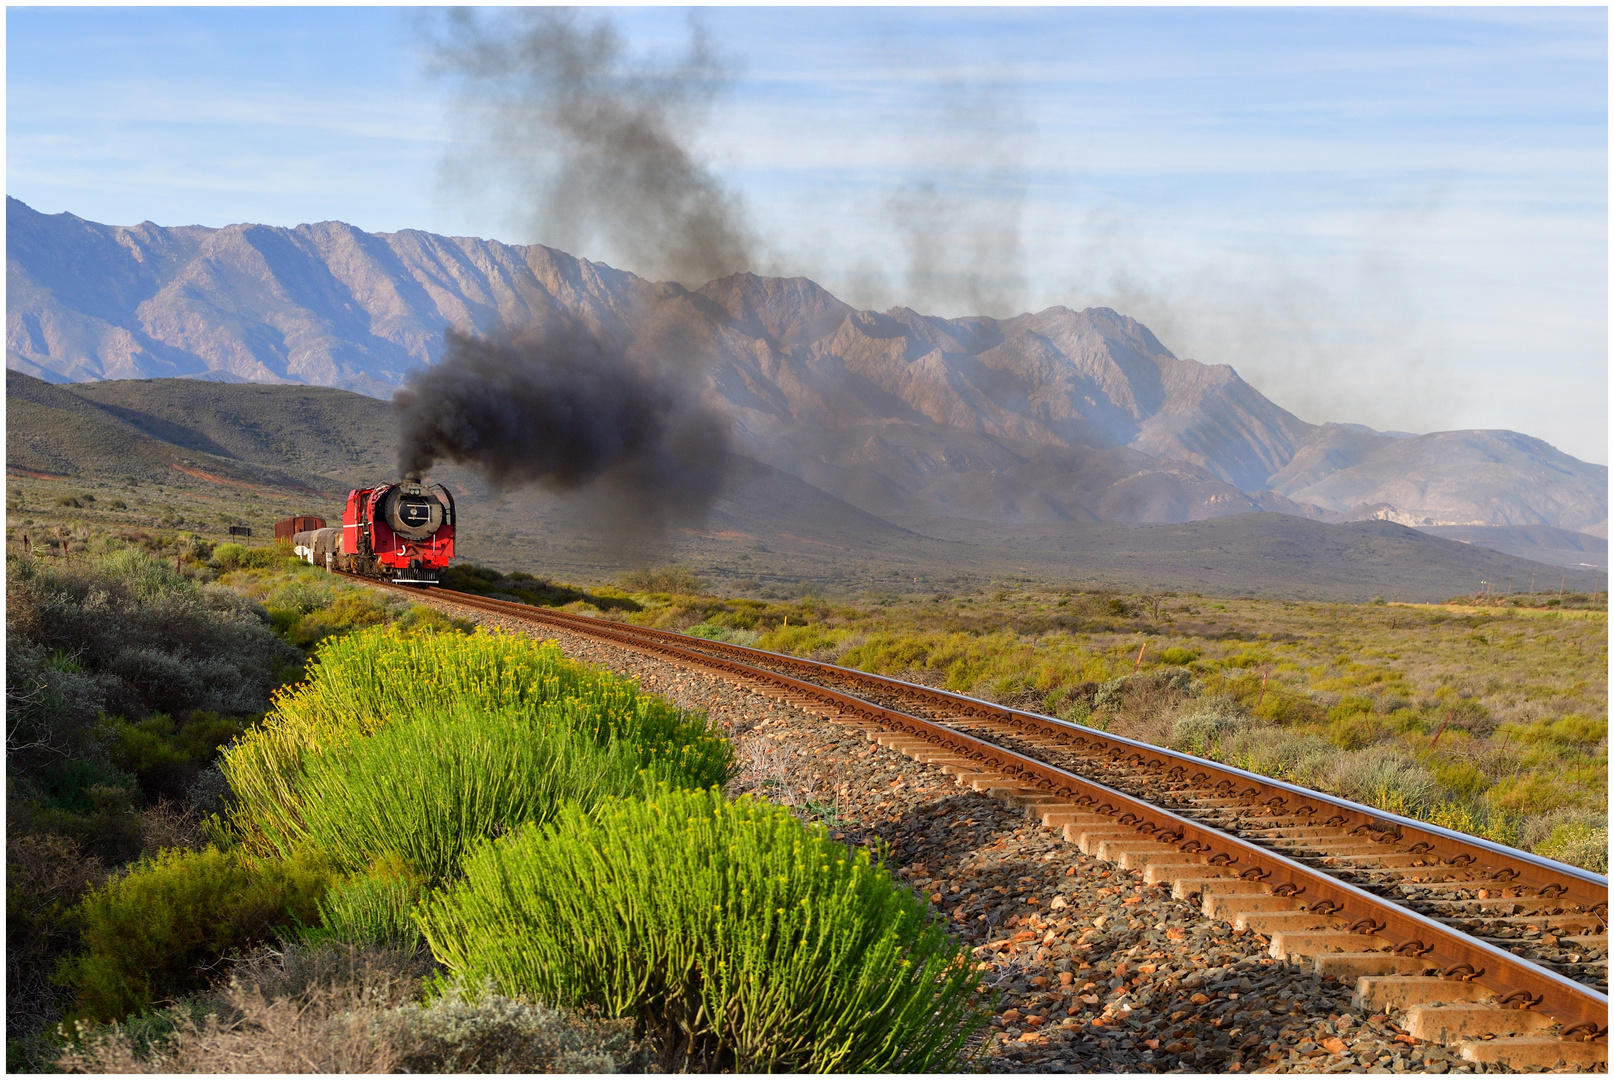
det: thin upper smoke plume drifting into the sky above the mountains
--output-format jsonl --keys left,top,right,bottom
{"left": 433, "top": 8, "right": 754, "bottom": 287}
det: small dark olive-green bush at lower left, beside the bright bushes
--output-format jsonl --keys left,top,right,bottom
{"left": 58, "top": 849, "right": 334, "bottom": 1020}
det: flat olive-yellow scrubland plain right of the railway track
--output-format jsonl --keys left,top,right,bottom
{"left": 568, "top": 570, "right": 1608, "bottom": 873}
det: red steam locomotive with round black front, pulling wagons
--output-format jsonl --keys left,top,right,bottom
{"left": 292, "top": 478, "right": 454, "bottom": 584}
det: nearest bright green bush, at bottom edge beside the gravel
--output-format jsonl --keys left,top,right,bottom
{"left": 420, "top": 788, "right": 981, "bottom": 1072}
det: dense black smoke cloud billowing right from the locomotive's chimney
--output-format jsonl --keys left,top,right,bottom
{"left": 392, "top": 324, "right": 728, "bottom": 538}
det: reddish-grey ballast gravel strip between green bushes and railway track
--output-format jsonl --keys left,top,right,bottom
{"left": 416, "top": 599, "right": 1536, "bottom": 1074}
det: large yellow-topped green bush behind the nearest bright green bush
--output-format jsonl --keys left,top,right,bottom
{"left": 221, "top": 628, "right": 734, "bottom": 877}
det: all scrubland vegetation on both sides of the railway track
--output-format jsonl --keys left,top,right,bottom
{"left": 6, "top": 516, "right": 1608, "bottom": 1072}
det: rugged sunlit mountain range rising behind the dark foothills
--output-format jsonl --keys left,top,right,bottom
{"left": 6, "top": 199, "right": 1608, "bottom": 548}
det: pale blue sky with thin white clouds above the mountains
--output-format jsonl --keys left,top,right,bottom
{"left": 6, "top": 8, "right": 1608, "bottom": 462}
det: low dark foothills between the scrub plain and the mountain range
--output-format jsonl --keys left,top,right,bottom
{"left": 6, "top": 371, "right": 1596, "bottom": 601}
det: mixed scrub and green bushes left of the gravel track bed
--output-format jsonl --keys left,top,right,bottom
{"left": 6, "top": 541, "right": 983, "bottom": 1072}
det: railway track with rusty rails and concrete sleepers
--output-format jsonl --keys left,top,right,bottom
{"left": 350, "top": 581, "right": 1608, "bottom": 1069}
